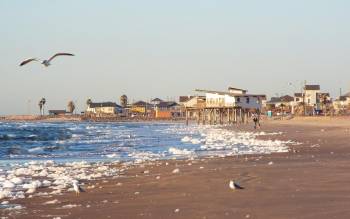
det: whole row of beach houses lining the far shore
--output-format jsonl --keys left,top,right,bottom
{"left": 52, "top": 85, "right": 350, "bottom": 123}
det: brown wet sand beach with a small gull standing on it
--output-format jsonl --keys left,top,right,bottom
{"left": 1, "top": 118, "right": 350, "bottom": 218}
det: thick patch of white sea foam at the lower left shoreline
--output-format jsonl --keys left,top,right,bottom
{"left": 0, "top": 161, "right": 119, "bottom": 200}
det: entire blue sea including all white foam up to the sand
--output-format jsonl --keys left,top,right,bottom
{"left": 0, "top": 122, "right": 293, "bottom": 201}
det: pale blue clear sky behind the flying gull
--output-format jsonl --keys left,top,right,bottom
{"left": 0, "top": 0, "right": 350, "bottom": 115}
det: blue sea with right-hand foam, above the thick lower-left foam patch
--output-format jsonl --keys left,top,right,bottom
{"left": 0, "top": 122, "right": 288, "bottom": 162}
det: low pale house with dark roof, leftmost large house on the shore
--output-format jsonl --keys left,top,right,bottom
{"left": 86, "top": 102, "right": 122, "bottom": 115}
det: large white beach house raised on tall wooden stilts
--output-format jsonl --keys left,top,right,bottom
{"left": 185, "top": 87, "right": 266, "bottom": 124}
